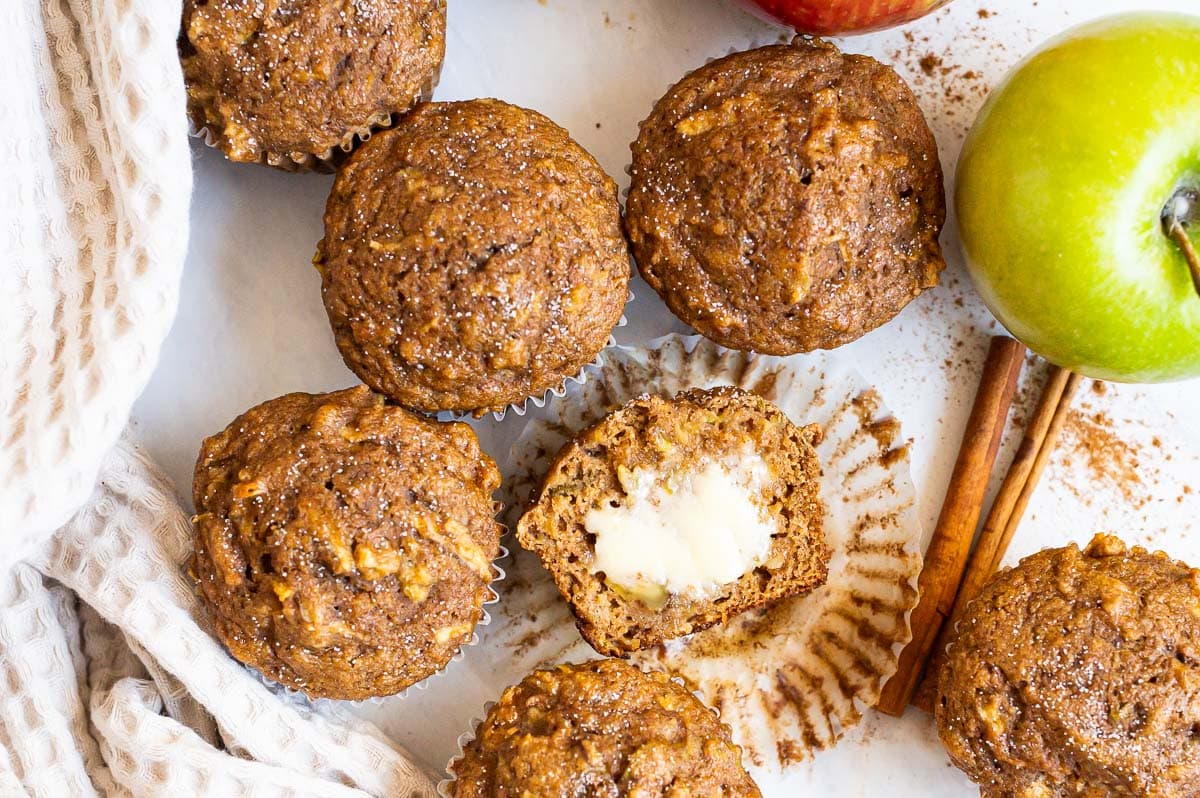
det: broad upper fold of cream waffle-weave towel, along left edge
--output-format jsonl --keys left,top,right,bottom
{"left": 0, "top": 0, "right": 192, "bottom": 570}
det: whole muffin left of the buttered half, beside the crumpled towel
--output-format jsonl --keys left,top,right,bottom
{"left": 191, "top": 386, "right": 500, "bottom": 700}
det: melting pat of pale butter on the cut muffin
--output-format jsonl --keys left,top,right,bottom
{"left": 583, "top": 448, "right": 778, "bottom": 608}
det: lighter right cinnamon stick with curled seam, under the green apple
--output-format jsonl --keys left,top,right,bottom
{"left": 912, "top": 366, "right": 1081, "bottom": 712}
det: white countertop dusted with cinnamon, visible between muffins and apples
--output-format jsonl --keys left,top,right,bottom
{"left": 134, "top": 0, "right": 1200, "bottom": 798}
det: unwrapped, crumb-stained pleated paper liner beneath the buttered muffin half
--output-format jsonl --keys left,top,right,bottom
{"left": 484, "top": 336, "right": 923, "bottom": 768}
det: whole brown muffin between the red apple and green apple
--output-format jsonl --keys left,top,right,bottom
{"left": 626, "top": 38, "right": 946, "bottom": 355}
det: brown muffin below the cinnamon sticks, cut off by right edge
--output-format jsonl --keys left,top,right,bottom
{"left": 937, "top": 535, "right": 1200, "bottom": 798}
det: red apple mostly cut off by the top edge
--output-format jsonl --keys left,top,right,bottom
{"left": 752, "top": 0, "right": 950, "bottom": 36}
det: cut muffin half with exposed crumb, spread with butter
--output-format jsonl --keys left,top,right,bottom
{"left": 517, "top": 388, "right": 829, "bottom": 656}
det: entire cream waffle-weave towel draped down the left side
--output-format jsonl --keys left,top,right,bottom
{"left": 0, "top": 0, "right": 434, "bottom": 798}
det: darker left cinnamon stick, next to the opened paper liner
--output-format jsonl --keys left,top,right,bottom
{"left": 876, "top": 336, "right": 1025, "bottom": 715}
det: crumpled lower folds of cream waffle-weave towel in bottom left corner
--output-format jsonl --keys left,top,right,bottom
{"left": 0, "top": 444, "right": 434, "bottom": 798}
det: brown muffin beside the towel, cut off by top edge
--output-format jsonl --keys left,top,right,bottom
{"left": 180, "top": 0, "right": 446, "bottom": 166}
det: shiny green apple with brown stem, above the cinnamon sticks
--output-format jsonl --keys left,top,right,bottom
{"left": 955, "top": 13, "right": 1200, "bottom": 382}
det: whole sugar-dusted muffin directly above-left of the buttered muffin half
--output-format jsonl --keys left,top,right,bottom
{"left": 316, "top": 100, "right": 629, "bottom": 412}
